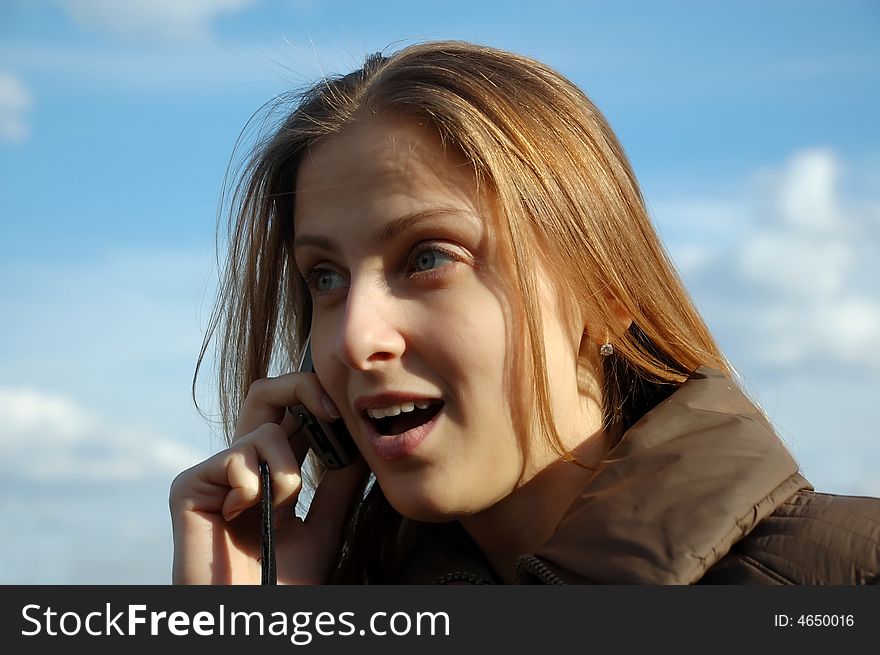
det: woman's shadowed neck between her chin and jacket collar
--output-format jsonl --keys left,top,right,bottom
{"left": 460, "top": 432, "right": 607, "bottom": 583}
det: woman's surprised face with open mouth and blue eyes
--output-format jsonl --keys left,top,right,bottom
{"left": 294, "top": 117, "right": 595, "bottom": 521}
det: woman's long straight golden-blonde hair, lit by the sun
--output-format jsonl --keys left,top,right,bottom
{"left": 193, "top": 41, "right": 730, "bottom": 580}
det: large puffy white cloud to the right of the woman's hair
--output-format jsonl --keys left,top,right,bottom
{"left": 658, "top": 148, "right": 880, "bottom": 372}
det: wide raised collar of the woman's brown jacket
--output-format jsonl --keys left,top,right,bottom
{"left": 397, "top": 368, "right": 811, "bottom": 584}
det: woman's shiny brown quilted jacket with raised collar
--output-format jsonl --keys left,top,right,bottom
{"left": 392, "top": 368, "right": 880, "bottom": 584}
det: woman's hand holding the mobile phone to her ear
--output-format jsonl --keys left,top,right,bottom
{"left": 169, "top": 373, "right": 367, "bottom": 584}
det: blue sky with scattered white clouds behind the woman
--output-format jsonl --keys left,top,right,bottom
{"left": 0, "top": 0, "right": 880, "bottom": 584}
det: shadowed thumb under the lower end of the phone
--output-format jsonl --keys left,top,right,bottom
{"left": 305, "top": 456, "right": 370, "bottom": 543}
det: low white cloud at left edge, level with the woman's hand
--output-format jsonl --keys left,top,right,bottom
{"left": 0, "top": 387, "right": 206, "bottom": 485}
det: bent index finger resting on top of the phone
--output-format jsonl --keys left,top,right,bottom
{"left": 235, "top": 373, "right": 339, "bottom": 439}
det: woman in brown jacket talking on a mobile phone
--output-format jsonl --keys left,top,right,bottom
{"left": 170, "top": 42, "right": 880, "bottom": 584}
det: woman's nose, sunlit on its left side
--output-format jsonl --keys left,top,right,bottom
{"left": 336, "top": 278, "right": 405, "bottom": 371}
